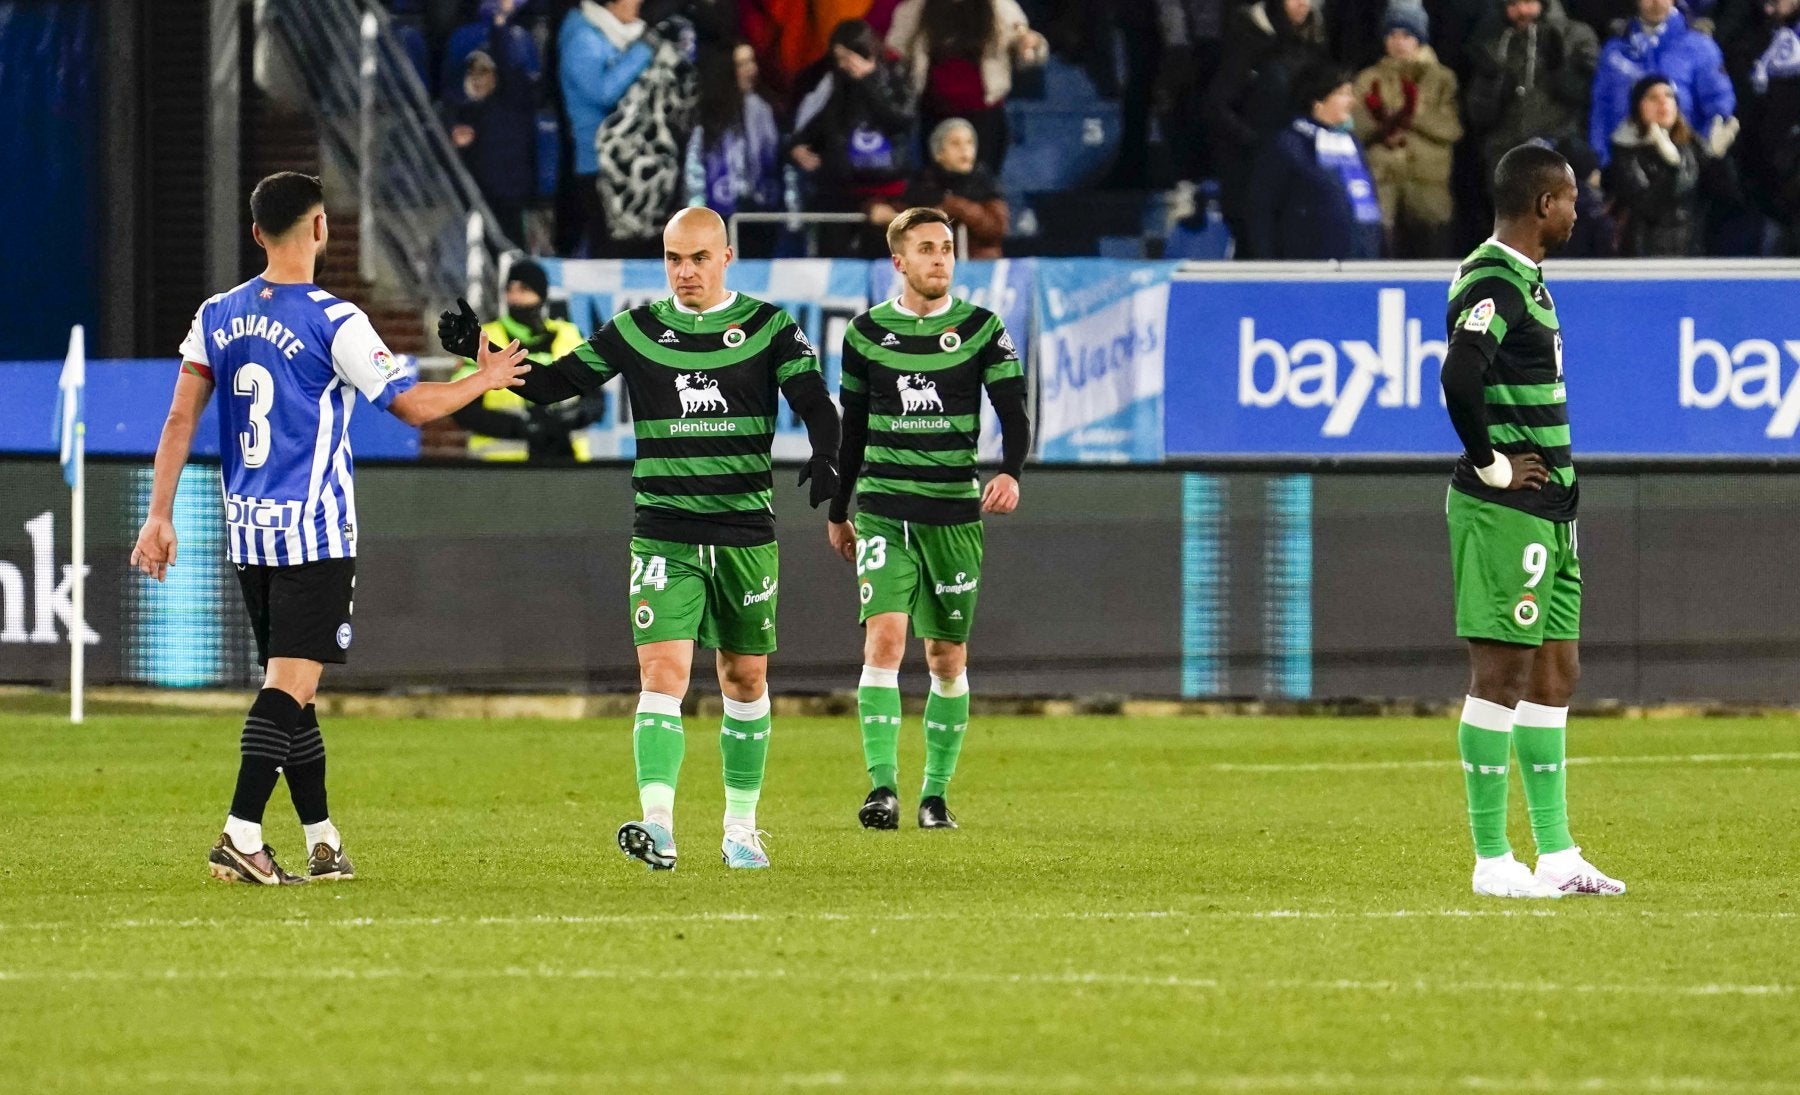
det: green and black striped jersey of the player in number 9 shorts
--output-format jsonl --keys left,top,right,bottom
{"left": 1445, "top": 240, "right": 1579, "bottom": 522}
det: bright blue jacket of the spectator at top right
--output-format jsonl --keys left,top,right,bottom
{"left": 1588, "top": 0, "right": 1737, "bottom": 164}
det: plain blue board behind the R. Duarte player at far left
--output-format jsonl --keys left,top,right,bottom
{"left": 0, "top": 355, "right": 419, "bottom": 459}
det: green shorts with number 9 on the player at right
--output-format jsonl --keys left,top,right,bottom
{"left": 1445, "top": 488, "right": 1580, "bottom": 647}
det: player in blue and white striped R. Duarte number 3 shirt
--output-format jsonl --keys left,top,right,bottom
{"left": 131, "top": 171, "right": 526, "bottom": 886}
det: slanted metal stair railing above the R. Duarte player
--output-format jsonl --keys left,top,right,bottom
{"left": 257, "top": 0, "right": 515, "bottom": 310}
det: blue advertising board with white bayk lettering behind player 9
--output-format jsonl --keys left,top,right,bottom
{"left": 1165, "top": 270, "right": 1800, "bottom": 461}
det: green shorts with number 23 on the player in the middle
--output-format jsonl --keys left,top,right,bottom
{"left": 857, "top": 513, "right": 981, "bottom": 643}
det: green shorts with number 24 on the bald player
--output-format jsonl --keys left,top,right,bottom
{"left": 632, "top": 537, "right": 781, "bottom": 654}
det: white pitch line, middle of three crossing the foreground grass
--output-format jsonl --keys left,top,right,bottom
{"left": 0, "top": 965, "right": 1796, "bottom": 998}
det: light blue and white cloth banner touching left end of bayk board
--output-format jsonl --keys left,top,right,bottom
{"left": 1033, "top": 259, "right": 1186, "bottom": 463}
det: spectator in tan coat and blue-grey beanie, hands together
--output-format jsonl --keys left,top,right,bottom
{"left": 1354, "top": 4, "right": 1462, "bottom": 259}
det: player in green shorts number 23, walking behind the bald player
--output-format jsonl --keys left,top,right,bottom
{"left": 826, "top": 207, "right": 1031, "bottom": 828}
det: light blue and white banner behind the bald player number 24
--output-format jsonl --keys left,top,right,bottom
{"left": 538, "top": 259, "right": 869, "bottom": 459}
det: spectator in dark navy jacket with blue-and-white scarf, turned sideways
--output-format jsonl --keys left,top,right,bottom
{"left": 1247, "top": 63, "right": 1382, "bottom": 259}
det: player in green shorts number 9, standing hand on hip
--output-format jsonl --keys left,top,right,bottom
{"left": 1442, "top": 144, "right": 1625, "bottom": 897}
